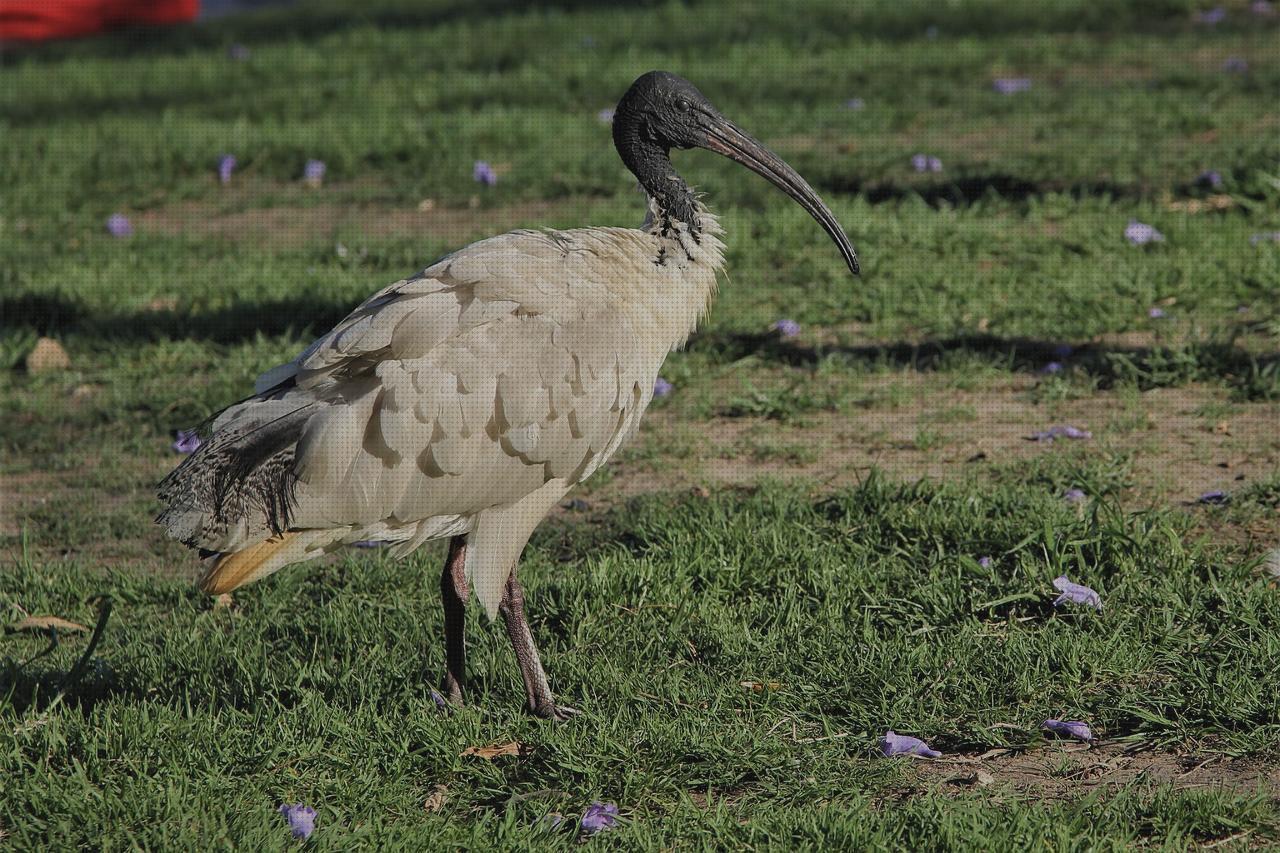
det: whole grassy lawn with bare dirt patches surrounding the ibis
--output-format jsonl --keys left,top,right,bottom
{"left": 0, "top": 0, "right": 1280, "bottom": 850}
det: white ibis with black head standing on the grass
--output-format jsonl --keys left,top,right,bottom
{"left": 157, "top": 72, "right": 858, "bottom": 719}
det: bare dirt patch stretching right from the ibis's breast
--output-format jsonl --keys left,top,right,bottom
{"left": 589, "top": 375, "right": 1280, "bottom": 506}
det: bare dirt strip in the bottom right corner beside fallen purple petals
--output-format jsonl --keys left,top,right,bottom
{"left": 915, "top": 744, "right": 1280, "bottom": 800}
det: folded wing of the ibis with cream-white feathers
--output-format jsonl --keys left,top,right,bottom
{"left": 259, "top": 232, "right": 659, "bottom": 528}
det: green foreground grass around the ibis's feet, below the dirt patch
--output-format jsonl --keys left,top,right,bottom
{"left": 0, "top": 471, "right": 1280, "bottom": 849}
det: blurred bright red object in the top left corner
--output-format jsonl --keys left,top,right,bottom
{"left": 0, "top": 0, "right": 200, "bottom": 41}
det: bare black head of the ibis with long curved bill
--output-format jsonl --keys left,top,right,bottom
{"left": 613, "top": 70, "right": 858, "bottom": 275}
